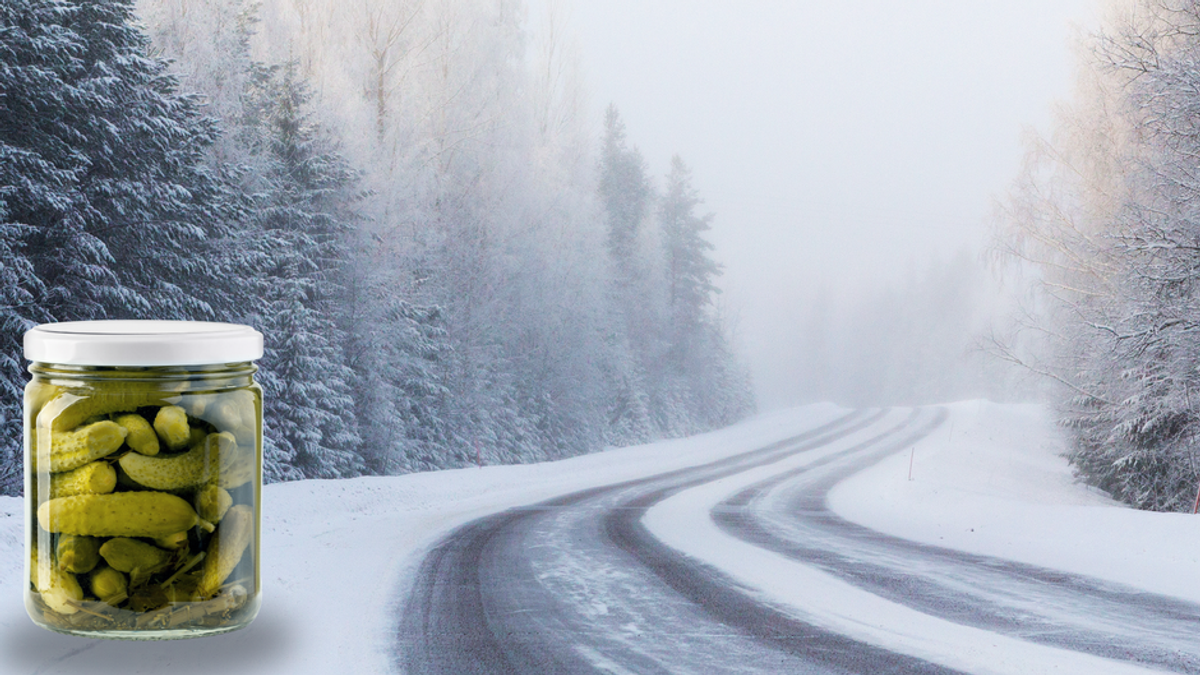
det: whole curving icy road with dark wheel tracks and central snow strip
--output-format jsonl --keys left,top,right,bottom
{"left": 395, "top": 410, "right": 1200, "bottom": 675}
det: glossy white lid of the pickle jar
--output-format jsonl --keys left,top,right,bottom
{"left": 25, "top": 321, "right": 263, "bottom": 366}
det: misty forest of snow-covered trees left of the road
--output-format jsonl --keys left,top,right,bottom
{"left": 0, "top": 0, "right": 752, "bottom": 489}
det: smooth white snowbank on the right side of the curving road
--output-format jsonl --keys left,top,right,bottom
{"left": 829, "top": 401, "right": 1200, "bottom": 602}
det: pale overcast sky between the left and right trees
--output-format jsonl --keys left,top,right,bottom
{"left": 532, "top": 0, "right": 1098, "bottom": 407}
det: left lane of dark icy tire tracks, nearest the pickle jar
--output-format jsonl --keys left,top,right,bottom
{"left": 395, "top": 411, "right": 969, "bottom": 675}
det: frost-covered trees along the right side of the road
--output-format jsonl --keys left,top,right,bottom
{"left": 1000, "top": 0, "right": 1200, "bottom": 510}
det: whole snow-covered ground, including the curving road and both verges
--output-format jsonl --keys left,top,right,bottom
{"left": 0, "top": 401, "right": 1200, "bottom": 675}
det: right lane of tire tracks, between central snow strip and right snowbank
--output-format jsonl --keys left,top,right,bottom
{"left": 712, "top": 408, "right": 1200, "bottom": 674}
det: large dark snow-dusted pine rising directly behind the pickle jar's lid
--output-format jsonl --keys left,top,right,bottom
{"left": 25, "top": 0, "right": 236, "bottom": 321}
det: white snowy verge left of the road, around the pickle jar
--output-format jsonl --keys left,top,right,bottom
{"left": 0, "top": 405, "right": 846, "bottom": 675}
